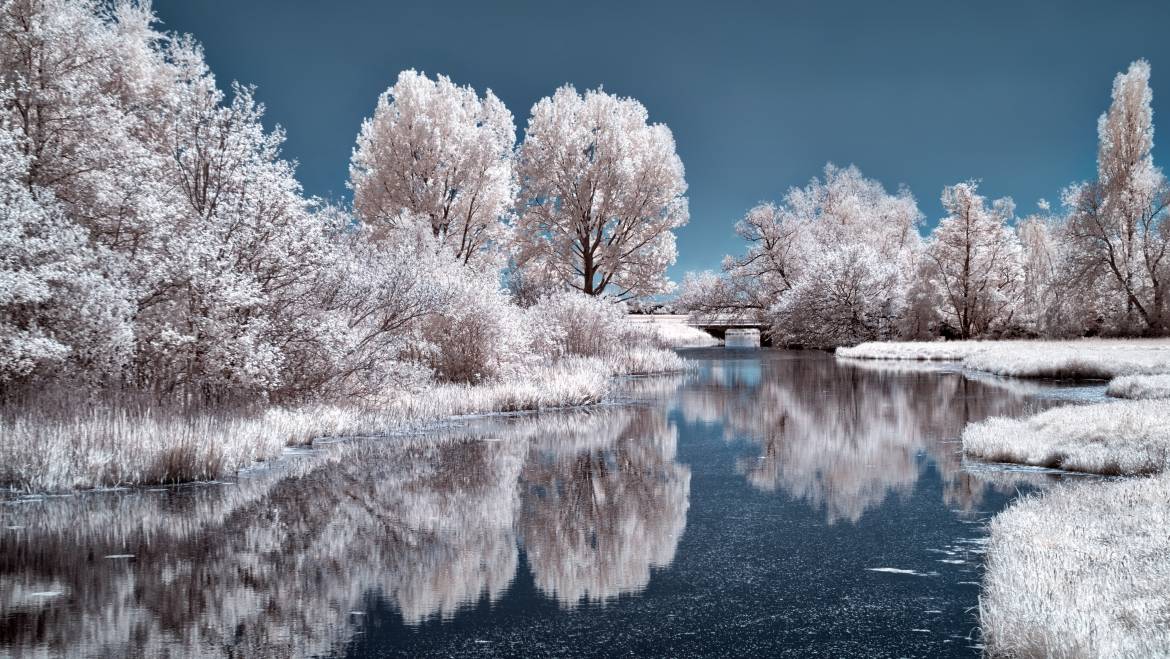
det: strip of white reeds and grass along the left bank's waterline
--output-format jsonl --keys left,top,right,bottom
{"left": 0, "top": 345, "right": 687, "bottom": 492}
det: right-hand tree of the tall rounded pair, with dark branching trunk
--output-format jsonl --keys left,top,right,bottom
{"left": 515, "top": 85, "right": 688, "bottom": 300}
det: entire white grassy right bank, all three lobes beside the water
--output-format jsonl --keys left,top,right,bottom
{"left": 837, "top": 339, "right": 1170, "bottom": 657}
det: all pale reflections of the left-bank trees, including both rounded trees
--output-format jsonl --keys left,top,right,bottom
{"left": 0, "top": 407, "right": 689, "bottom": 655}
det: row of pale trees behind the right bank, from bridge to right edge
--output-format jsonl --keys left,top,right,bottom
{"left": 680, "top": 60, "right": 1170, "bottom": 346}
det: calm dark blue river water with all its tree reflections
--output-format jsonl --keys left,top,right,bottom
{"left": 0, "top": 350, "right": 1102, "bottom": 657}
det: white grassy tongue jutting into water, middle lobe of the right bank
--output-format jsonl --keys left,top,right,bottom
{"left": 963, "top": 400, "right": 1170, "bottom": 475}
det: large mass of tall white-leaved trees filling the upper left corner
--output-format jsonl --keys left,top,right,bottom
{"left": 0, "top": 0, "right": 374, "bottom": 400}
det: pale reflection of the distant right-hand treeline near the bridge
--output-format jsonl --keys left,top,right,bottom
{"left": 676, "top": 352, "right": 1057, "bottom": 523}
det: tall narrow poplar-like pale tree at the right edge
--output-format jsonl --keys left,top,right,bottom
{"left": 1065, "top": 60, "right": 1170, "bottom": 334}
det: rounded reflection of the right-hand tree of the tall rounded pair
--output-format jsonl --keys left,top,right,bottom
{"left": 519, "top": 407, "right": 690, "bottom": 606}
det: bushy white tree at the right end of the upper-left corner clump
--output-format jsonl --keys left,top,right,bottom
{"left": 139, "top": 84, "right": 331, "bottom": 400}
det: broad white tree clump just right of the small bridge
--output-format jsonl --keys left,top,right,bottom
{"left": 682, "top": 164, "right": 922, "bottom": 345}
